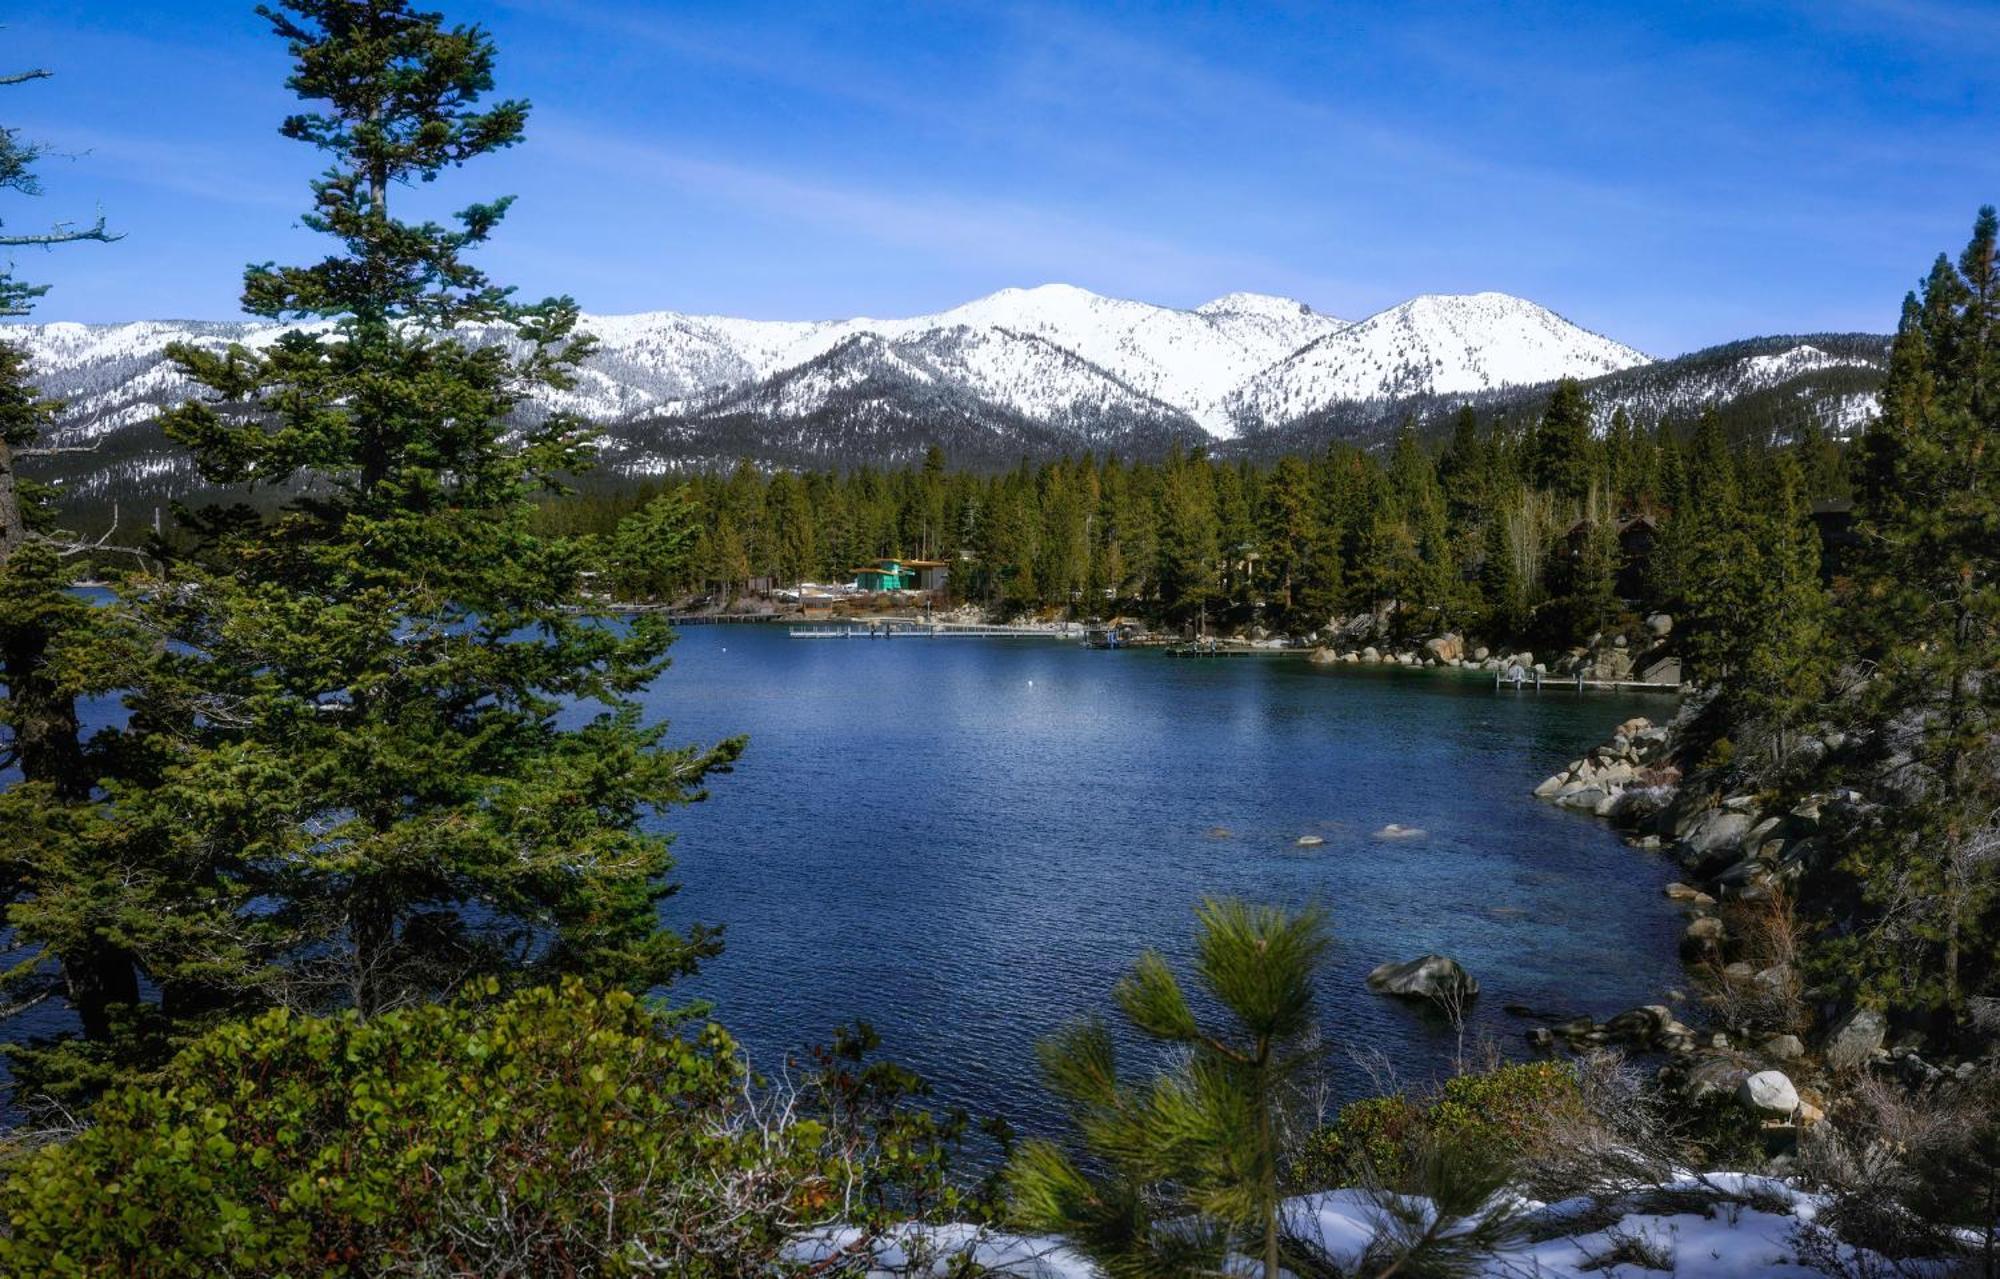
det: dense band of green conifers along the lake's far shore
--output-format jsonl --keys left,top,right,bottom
{"left": 538, "top": 382, "right": 1852, "bottom": 695}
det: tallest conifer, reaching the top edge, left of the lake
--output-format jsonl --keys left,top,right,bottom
{"left": 142, "top": 0, "right": 740, "bottom": 1015}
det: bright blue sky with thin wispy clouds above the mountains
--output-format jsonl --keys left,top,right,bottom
{"left": 0, "top": 0, "right": 2000, "bottom": 354}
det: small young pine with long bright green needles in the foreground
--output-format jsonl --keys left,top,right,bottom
{"left": 1008, "top": 899, "right": 1330, "bottom": 1279}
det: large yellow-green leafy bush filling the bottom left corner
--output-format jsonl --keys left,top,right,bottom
{"left": 0, "top": 981, "right": 962, "bottom": 1275}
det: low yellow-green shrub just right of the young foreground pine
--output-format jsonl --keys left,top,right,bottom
{"left": 1292, "top": 1061, "right": 1582, "bottom": 1189}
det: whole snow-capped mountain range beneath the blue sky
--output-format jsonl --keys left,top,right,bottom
{"left": 6, "top": 284, "right": 1880, "bottom": 496}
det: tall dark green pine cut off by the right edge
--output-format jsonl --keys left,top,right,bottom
{"left": 1830, "top": 206, "right": 2000, "bottom": 1017}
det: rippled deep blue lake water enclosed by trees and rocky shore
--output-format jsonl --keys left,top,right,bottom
{"left": 646, "top": 626, "right": 1680, "bottom": 1129}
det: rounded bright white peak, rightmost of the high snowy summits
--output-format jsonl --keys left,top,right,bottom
{"left": 1230, "top": 294, "right": 1650, "bottom": 424}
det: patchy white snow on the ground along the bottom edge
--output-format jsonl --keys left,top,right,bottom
{"left": 794, "top": 1173, "right": 1952, "bottom": 1279}
